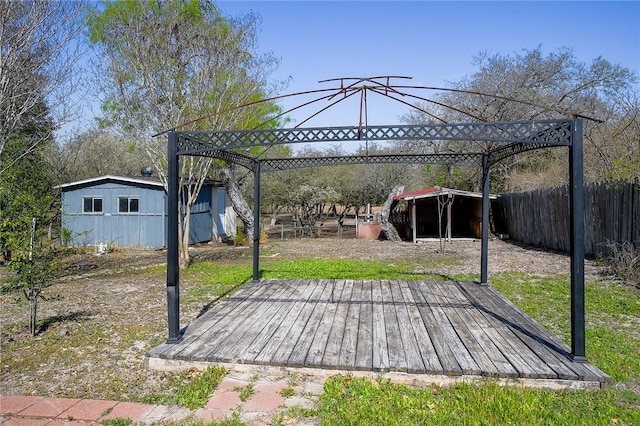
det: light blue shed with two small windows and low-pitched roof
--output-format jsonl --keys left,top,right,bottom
{"left": 60, "top": 175, "right": 236, "bottom": 248}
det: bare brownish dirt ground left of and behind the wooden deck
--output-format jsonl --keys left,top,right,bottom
{"left": 0, "top": 237, "right": 602, "bottom": 400}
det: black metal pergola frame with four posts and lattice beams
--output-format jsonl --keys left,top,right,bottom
{"left": 167, "top": 116, "right": 587, "bottom": 362}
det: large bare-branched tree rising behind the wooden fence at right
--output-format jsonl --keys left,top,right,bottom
{"left": 407, "top": 48, "right": 640, "bottom": 190}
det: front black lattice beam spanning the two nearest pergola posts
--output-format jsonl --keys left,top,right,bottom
{"left": 178, "top": 120, "right": 571, "bottom": 155}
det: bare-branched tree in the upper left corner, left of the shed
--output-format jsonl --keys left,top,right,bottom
{"left": 0, "top": 0, "right": 84, "bottom": 175}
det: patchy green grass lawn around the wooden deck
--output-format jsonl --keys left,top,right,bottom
{"left": 3, "top": 241, "right": 640, "bottom": 425}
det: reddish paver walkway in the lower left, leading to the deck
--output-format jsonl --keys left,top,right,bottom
{"left": 0, "top": 371, "right": 323, "bottom": 426}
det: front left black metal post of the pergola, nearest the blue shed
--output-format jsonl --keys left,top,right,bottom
{"left": 167, "top": 131, "right": 182, "bottom": 344}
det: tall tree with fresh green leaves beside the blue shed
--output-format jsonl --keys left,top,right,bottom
{"left": 89, "top": 0, "right": 276, "bottom": 266}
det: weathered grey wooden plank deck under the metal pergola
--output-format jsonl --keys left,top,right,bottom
{"left": 148, "top": 279, "right": 610, "bottom": 385}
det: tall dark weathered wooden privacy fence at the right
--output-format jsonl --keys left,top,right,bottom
{"left": 493, "top": 181, "right": 640, "bottom": 257}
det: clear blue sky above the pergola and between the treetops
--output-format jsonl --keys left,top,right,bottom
{"left": 218, "top": 1, "right": 640, "bottom": 127}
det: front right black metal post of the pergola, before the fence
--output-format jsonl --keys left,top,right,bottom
{"left": 569, "top": 117, "right": 587, "bottom": 362}
